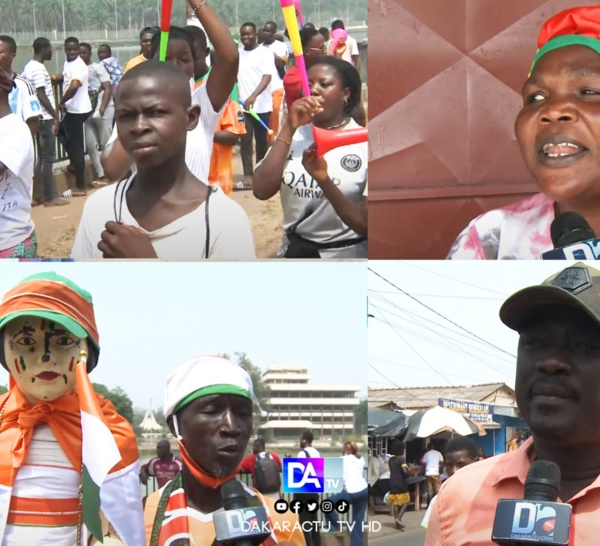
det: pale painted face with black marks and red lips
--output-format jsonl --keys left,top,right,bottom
{"left": 4, "top": 316, "right": 88, "bottom": 404}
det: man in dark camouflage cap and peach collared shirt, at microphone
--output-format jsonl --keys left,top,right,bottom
{"left": 425, "top": 263, "right": 600, "bottom": 546}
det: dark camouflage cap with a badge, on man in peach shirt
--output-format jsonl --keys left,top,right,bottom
{"left": 500, "top": 262, "right": 600, "bottom": 332}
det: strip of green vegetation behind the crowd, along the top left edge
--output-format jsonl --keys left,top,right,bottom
{"left": 0, "top": 0, "right": 367, "bottom": 37}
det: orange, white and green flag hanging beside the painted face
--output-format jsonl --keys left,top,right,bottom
{"left": 75, "top": 351, "right": 121, "bottom": 542}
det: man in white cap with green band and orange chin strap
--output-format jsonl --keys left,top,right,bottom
{"left": 144, "top": 355, "right": 305, "bottom": 546}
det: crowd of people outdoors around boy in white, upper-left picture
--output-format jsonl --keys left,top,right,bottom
{"left": 0, "top": 0, "right": 368, "bottom": 260}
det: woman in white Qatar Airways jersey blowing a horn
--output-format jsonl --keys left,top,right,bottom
{"left": 253, "top": 56, "right": 368, "bottom": 258}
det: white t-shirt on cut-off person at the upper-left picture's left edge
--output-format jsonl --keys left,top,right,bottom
{"left": 0, "top": 114, "right": 34, "bottom": 250}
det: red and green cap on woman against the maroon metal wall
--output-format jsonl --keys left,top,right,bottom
{"left": 530, "top": 6, "right": 600, "bottom": 72}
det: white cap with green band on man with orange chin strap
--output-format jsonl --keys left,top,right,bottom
{"left": 163, "top": 355, "right": 258, "bottom": 418}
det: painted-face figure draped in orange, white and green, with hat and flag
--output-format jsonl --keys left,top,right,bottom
{"left": 0, "top": 273, "right": 145, "bottom": 546}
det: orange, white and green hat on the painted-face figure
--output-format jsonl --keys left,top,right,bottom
{"left": 0, "top": 272, "right": 100, "bottom": 371}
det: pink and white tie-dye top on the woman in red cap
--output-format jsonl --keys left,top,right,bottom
{"left": 448, "top": 193, "right": 556, "bottom": 260}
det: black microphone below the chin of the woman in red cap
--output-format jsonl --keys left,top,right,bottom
{"left": 541, "top": 212, "right": 600, "bottom": 260}
